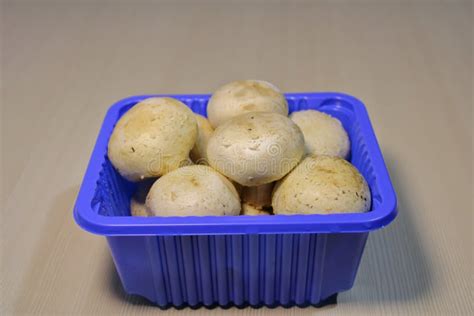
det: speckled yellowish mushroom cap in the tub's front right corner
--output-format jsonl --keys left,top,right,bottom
{"left": 272, "top": 156, "right": 371, "bottom": 214}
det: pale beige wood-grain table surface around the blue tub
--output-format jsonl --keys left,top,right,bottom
{"left": 0, "top": 0, "right": 474, "bottom": 315}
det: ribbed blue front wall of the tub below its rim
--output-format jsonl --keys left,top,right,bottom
{"left": 107, "top": 233, "right": 368, "bottom": 307}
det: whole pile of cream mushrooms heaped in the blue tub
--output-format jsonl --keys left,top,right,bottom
{"left": 108, "top": 80, "right": 371, "bottom": 216}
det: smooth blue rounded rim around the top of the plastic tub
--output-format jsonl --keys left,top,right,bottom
{"left": 73, "top": 92, "right": 397, "bottom": 236}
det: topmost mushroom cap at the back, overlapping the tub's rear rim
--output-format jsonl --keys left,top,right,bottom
{"left": 207, "top": 80, "right": 288, "bottom": 128}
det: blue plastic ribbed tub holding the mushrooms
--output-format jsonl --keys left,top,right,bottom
{"left": 74, "top": 93, "right": 396, "bottom": 308}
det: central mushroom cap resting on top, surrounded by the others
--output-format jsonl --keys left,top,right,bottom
{"left": 207, "top": 112, "right": 304, "bottom": 186}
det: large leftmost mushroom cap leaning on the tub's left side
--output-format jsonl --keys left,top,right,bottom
{"left": 108, "top": 98, "right": 197, "bottom": 181}
